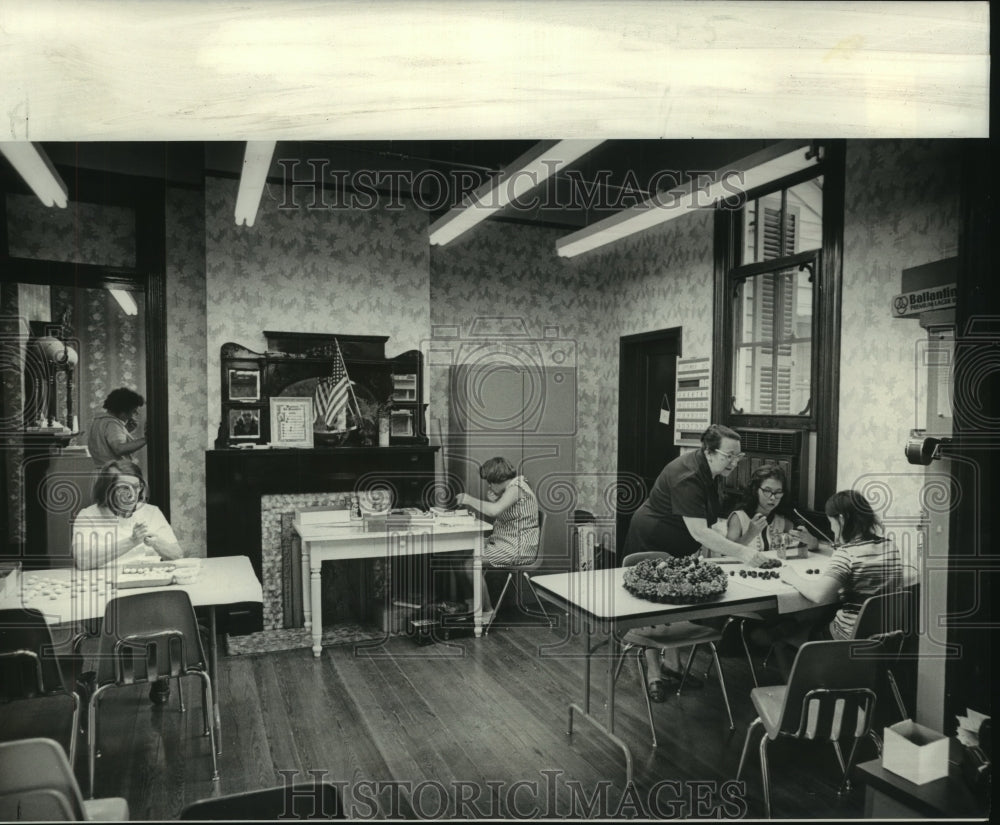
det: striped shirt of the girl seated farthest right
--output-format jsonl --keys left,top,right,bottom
{"left": 824, "top": 540, "right": 903, "bottom": 639}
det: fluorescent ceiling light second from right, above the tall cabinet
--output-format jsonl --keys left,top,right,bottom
{"left": 430, "top": 140, "right": 603, "bottom": 246}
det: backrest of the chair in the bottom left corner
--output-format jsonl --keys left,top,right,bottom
{"left": 0, "top": 738, "right": 87, "bottom": 822}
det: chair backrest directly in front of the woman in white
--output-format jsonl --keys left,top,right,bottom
{"left": 97, "top": 590, "right": 208, "bottom": 685}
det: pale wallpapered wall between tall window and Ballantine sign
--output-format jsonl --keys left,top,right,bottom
{"left": 837, "top": 140, "right": 961, "bottom": 521}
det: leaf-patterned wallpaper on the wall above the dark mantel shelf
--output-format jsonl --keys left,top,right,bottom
{"left": 202, "top": 177, "right": 430, "bottom": 446}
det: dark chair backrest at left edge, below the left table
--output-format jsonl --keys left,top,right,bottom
{"left": 0, "top": 608, "right": 71, "bottom": 702}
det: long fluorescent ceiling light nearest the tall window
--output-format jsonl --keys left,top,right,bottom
{"left": 556, "top": 140, "right": 818, "bottom": 258}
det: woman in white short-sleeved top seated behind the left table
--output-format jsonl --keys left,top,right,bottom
{"left": 73, "top": 459, "right": 184, "bottom": 570}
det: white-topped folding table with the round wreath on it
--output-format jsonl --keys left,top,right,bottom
{"left": 531, "top": 554, "right": 827, "bottom": 782}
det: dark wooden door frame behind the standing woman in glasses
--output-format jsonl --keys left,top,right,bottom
{"left": 617, "top": 327, "right": 684, "bottom": 547}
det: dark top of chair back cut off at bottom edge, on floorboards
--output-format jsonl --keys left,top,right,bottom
{"left": 180, "top": 782, "right": 347, "bottom": 822}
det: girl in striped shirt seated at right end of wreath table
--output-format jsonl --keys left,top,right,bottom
{"left": 751, "top": 490, "right": 903, "bottom": 674}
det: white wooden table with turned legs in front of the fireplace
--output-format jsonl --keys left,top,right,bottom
{"left": 293, "top": 517, "right": 493, "bottom": 656}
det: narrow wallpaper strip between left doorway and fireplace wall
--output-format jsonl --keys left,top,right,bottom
{"left": 166, "top": 187, "right": 208, "bottom": 556}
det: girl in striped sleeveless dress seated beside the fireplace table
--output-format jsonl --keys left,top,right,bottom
{"left": 456, "top": 456, "right": 538, "bottom": 613}
